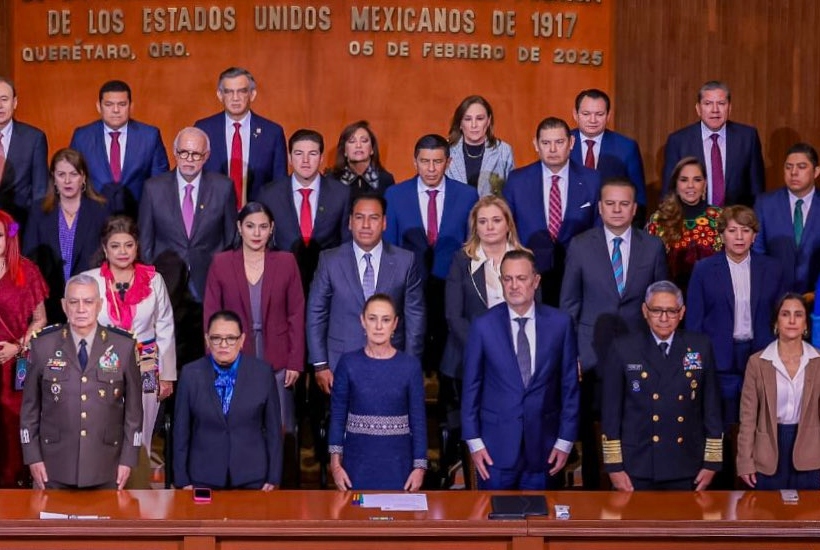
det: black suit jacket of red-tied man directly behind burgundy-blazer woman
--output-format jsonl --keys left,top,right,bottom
{"left": 257, "top": 176, "right": 350, "bottom": 293}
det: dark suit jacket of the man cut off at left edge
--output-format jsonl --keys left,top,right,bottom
{"left": 0, "top": 120, "right": 48, "bottom": 234}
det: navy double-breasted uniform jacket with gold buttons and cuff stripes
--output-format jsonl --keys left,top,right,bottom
{"left": 601, "top": 330, "right": 723, "bottom": 482}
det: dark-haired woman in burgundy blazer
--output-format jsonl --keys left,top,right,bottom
{"left": 203, "top": 202, "right": 305, "bottom": 433}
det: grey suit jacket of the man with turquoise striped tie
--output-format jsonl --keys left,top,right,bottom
{"left": 560, "top": 227, "right": 667, "bottom": 371}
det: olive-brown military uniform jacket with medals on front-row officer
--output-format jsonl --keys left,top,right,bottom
{"left": 20, "top": 325, "right": 142, "bottom": 487}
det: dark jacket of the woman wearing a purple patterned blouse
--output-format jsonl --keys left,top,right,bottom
{"left": 23, "top": 197, "right": 108, "bottom": 323}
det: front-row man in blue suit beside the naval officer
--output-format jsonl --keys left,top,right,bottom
{"left": 461, "top": 251, "right": 579, "bottom": 490}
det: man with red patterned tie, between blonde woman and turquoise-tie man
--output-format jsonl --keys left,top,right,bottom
{"left": 503, "top": 117, "right": 601, "bottom": 307}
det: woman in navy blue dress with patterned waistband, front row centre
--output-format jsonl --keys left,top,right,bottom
{"left": 328, "top": 294, "right": 427, "bottom": 491}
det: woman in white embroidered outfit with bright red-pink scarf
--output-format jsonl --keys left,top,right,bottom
{"left": 86, "top": 216, "right": 177, "bottom": 478}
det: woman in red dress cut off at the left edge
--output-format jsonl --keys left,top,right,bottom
{"left": 0, "top": 210, "right": 48, "bottom": 489}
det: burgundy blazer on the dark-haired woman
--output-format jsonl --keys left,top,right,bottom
{"left": 203, "top": 248, "right": 305, "bottom": 371}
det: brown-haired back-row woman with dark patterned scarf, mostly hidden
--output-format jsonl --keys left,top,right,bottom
{"left": 330, "top": 120, "right": 396, "bottom": 200}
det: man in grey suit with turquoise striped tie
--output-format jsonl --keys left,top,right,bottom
{"left": 561, "top": 179, "right": 667, "bottom": 489}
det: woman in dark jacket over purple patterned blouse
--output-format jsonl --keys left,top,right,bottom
{"left": 23, "top": 149, "right": 108, "bottom": 323}
